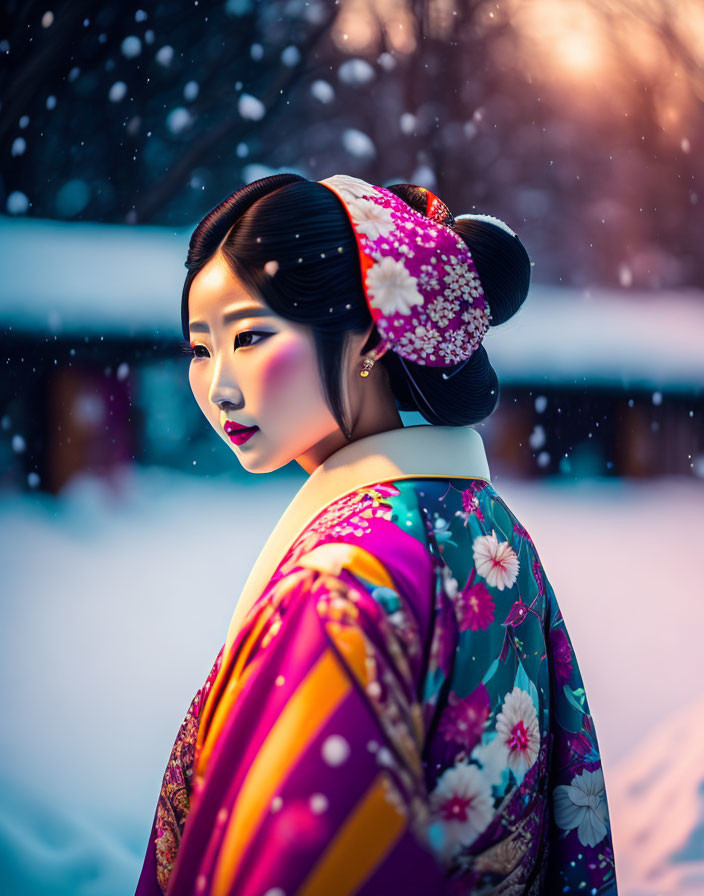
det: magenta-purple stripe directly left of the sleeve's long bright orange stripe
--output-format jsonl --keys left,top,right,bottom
{"left": 169, "top": 584, "right": 327, "bottom": 896}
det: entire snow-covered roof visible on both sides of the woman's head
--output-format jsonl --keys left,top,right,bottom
{"left": 0, "top": 216, "right": 704, "bottom": 389}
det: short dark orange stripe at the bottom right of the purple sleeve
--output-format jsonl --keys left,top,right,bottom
{"left": 296, "top": 772, "right": 406, "bottom": 896}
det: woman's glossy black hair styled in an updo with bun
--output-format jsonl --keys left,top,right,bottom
{"left": 181, "top": 174, "right": 530, "bottom": 440}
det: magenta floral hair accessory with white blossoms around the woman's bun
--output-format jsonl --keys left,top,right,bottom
{"left": 319, "top": 174, "right": 491, "bottom": 378}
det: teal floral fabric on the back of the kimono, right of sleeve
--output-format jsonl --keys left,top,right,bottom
{"left": 386, "top": 478, "right": 617, "bottom": 896}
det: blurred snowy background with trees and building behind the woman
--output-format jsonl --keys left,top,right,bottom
{"left": 0, "top": 0, "right": 704, "bottom": 896}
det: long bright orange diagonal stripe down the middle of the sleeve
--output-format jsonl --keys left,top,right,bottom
{"left": 212, "top": 649, "right": 351, "bottom": 896}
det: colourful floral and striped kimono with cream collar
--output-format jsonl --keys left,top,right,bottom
{"left": 137, "top": 425, "right": 617, "bottom": 896}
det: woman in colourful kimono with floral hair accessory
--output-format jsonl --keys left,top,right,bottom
{"left": 137, "top": 174, "right": 617, "bottom": 896}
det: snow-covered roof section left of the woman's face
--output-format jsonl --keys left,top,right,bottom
{"left": 0, "top": 215, "right": 190, "bottom": 337}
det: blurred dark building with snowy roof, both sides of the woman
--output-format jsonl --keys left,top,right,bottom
{"left": 0, "top": 217, "right": 704, "bottom": 493}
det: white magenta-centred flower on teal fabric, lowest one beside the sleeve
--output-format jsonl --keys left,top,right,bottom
{"left": 429, "top": 760, "right": 494, "bottom": 858}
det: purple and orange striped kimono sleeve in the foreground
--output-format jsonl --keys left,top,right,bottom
{"left": 162, "top": 521, "right": 444, "bottom": 896}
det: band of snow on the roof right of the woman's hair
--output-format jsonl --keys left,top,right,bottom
{"left": 484, "top": 284, "right": 704, "bottom": 391}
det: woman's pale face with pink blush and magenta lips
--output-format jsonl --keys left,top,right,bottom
{"left": 188, "top": 253, "right": 361, "bottom": 473}
